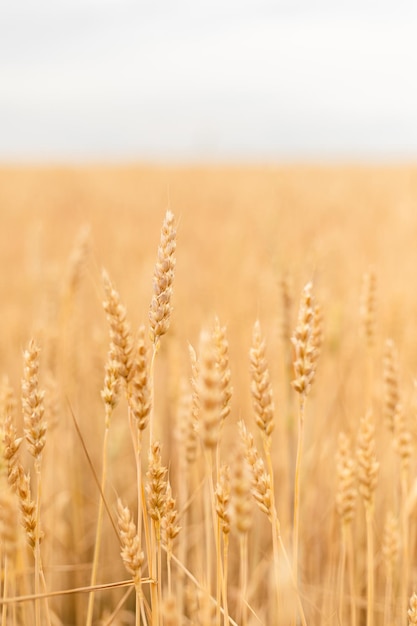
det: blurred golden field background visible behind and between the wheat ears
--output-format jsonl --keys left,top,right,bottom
{"left": 0, "top": 166, "right": 417, "bottom": 624}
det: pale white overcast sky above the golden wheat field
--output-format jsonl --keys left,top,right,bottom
{"left": 0, "top": 0, "right": 417, "bottom": 161}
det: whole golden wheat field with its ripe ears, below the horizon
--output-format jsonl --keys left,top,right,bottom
{"left": 0, "top": 166, "right": 417, "bottom": 626}
